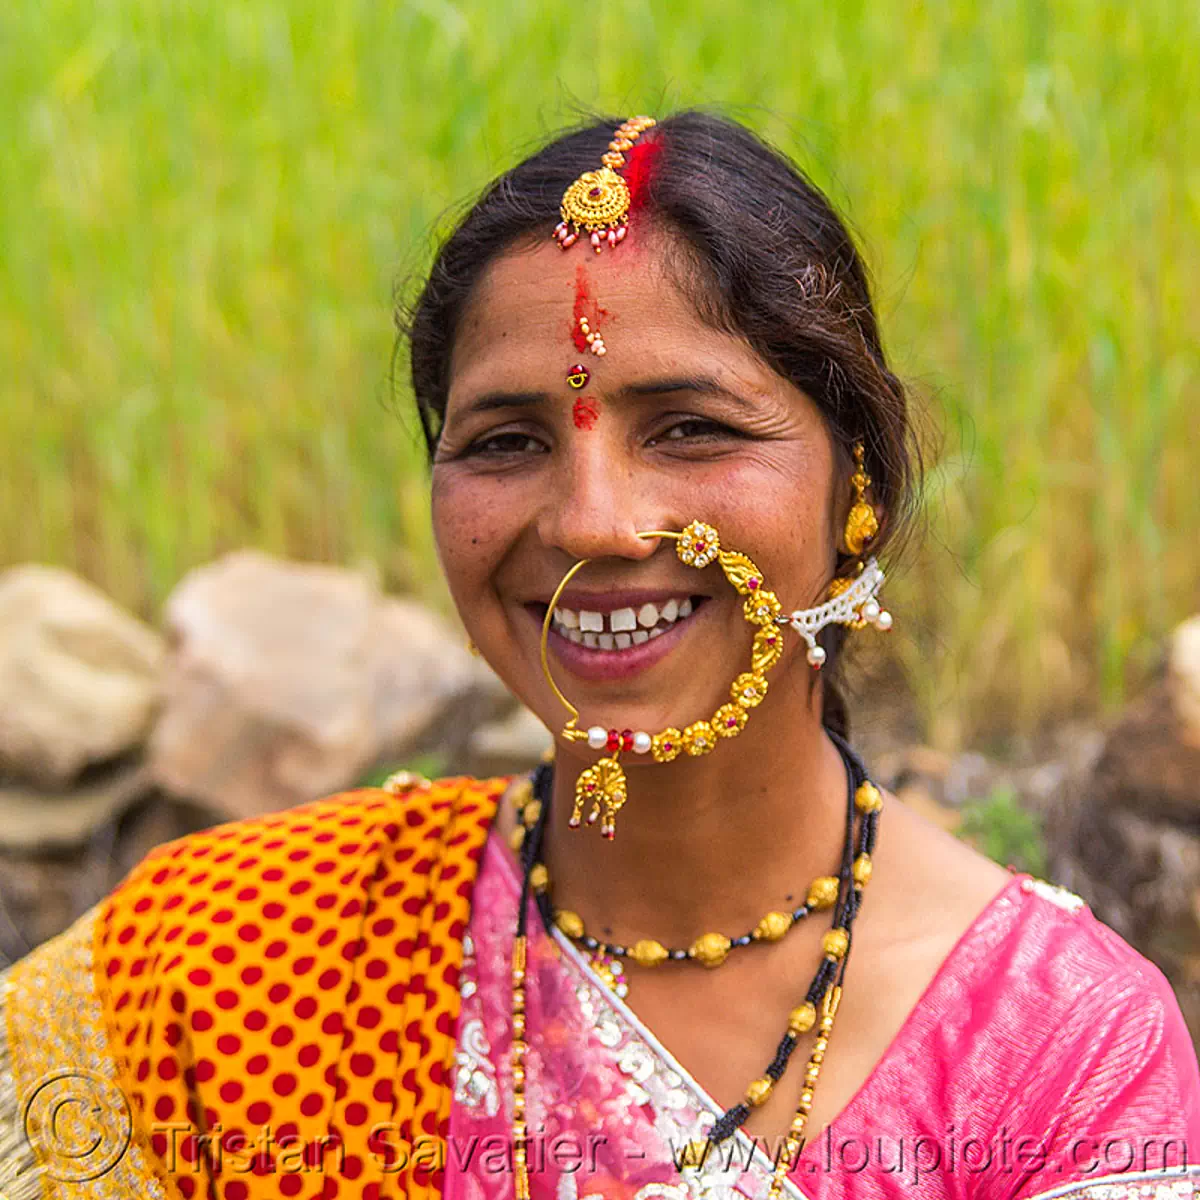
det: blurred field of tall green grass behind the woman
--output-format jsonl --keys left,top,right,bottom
{"left": 0, "top": 0, "right": 1200, "bottom": 744}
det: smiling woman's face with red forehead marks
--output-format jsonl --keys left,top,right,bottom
{"left": 433, "top": 230, "right": 840, "bottom": 733}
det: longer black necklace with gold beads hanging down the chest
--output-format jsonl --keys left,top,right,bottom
{"left": 514, "top": 730, "right": 881, "bottom": 1171}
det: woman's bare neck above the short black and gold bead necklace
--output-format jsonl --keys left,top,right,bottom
{"left": 544, "top": 689, "right": 846, "bottom": 947}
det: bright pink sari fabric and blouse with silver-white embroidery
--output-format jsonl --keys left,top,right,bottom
{"left": 445, "top": 836, "right": 1200, "bottom": 1200}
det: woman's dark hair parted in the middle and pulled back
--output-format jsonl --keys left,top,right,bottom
{"left": 398, "top": 110, "right": 919, "bottom": 733}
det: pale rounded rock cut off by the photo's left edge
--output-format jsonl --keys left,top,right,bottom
{"left": 0, "top": 565, "right": 162, "bottom": 788}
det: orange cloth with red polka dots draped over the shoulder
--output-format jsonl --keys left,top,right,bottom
{"left": 94, "top": 779, "right": 509, "bottom": 1200}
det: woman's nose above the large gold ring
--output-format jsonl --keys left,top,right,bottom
{"left": 538, "top": 436, "right": 662, "bottom": 562}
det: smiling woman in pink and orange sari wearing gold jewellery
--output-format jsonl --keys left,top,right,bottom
{"left": 0, "top": 113, "right": 1200, "bottom": 1200}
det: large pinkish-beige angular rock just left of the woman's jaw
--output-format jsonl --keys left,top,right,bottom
{"left": 148, "top": 551, "right": 511, "bottom": 817}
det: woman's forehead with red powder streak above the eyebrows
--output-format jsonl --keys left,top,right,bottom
{"left": 450, "top": 230, "right": 770, "bottom": 400}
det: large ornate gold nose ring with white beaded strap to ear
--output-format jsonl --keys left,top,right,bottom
{"left": 541, "top": 520, "right": 890, "bottom": 840}
